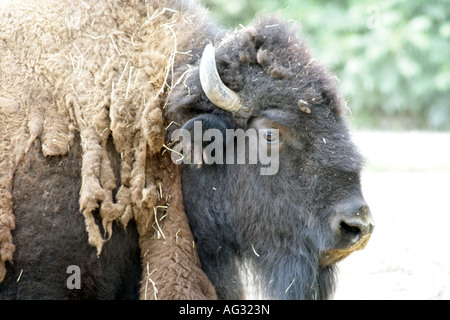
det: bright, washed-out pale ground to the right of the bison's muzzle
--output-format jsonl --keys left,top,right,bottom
{"left": 335, "top": 132, "right": 450, "bottom": 299}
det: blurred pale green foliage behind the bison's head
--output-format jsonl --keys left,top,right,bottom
{"left": 201, "top": 0, "right": 450, "bottom": 130}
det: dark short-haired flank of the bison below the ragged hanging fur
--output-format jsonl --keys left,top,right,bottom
{"left": 0, "top": 134, "right": 142, "bottom": 299}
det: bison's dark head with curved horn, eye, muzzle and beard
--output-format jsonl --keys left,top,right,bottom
{"left": 168, "top": 15, "right": 374, "bottom": 299}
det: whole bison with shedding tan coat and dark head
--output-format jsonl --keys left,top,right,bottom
{"left": 0, "top": 0, "right": 374, "bottom": 299}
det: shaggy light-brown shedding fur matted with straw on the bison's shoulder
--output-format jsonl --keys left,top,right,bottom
{"left": 0, "top": 0, "right": 215, "bottom": 299}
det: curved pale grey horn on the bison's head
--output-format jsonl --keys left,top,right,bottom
{"left": 200, "top": 44, "right": 241, "bottom": 112}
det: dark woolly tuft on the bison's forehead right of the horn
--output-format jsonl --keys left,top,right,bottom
{"left": 211, "top": 16, "right": 345, "bottom": 120}
